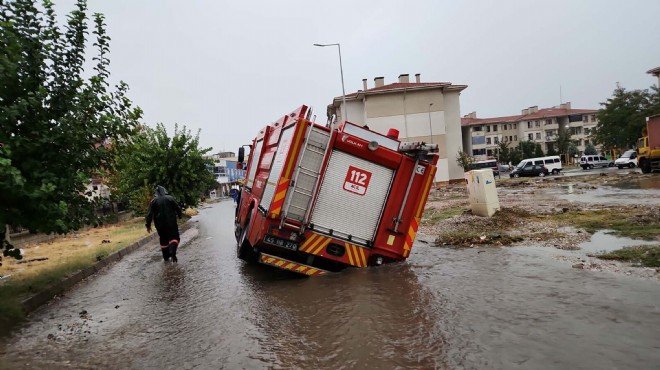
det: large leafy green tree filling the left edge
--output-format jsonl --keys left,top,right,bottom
{"left": 0, "top": 0, "right": 141, "bottom": 257}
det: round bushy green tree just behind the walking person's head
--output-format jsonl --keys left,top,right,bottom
{"left": 110, "top": 123, "right": 216, "bottom": 214}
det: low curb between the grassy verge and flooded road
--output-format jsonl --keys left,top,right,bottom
{"left": 21, "top": 219, "right": 193, "bottom": 315}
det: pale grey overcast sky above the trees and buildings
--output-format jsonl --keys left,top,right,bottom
{"left": 56, "top": 0, "right": 660, "bottom": 153}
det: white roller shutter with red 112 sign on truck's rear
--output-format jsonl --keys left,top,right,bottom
{"left": 310, "top": 150, "right": 394, "bottom": 243}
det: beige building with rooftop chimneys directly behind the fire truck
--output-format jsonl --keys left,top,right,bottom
{"left": 327, "top": 74, "right": 467, "bottom": 182}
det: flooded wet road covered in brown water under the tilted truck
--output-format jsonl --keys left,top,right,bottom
{"left": 0, "top": 202, "right": 660, "bottom": 369}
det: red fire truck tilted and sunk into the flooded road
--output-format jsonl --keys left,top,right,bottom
{"left": 235, "top": 105, "right": 438, "bottom": 275}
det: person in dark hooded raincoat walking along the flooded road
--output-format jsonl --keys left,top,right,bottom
{"left": 145, "top": 185, "right": 183, "bottom": 262}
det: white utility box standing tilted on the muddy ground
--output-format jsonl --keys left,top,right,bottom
{"left": 465, "top": 168, "right": 500, "bottom": 217}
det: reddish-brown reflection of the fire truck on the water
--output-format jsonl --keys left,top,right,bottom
{"left": 237, "top": 264, "right": 445, "bottom": 369}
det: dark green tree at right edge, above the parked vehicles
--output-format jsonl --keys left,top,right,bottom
{"left": 592, "top": 84, "right": 660, "bottom": 148}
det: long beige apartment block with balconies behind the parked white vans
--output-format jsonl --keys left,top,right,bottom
{"left": 461, "top": 102, "right": 600, "bottom": 158}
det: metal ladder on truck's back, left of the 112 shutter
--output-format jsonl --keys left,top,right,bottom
{"left": 280, "top": 123, "right": 330, "bottom": 232}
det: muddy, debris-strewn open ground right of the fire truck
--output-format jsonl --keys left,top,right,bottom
{"left": 419, "top": 172, "right": 660, "bottom": 264}
